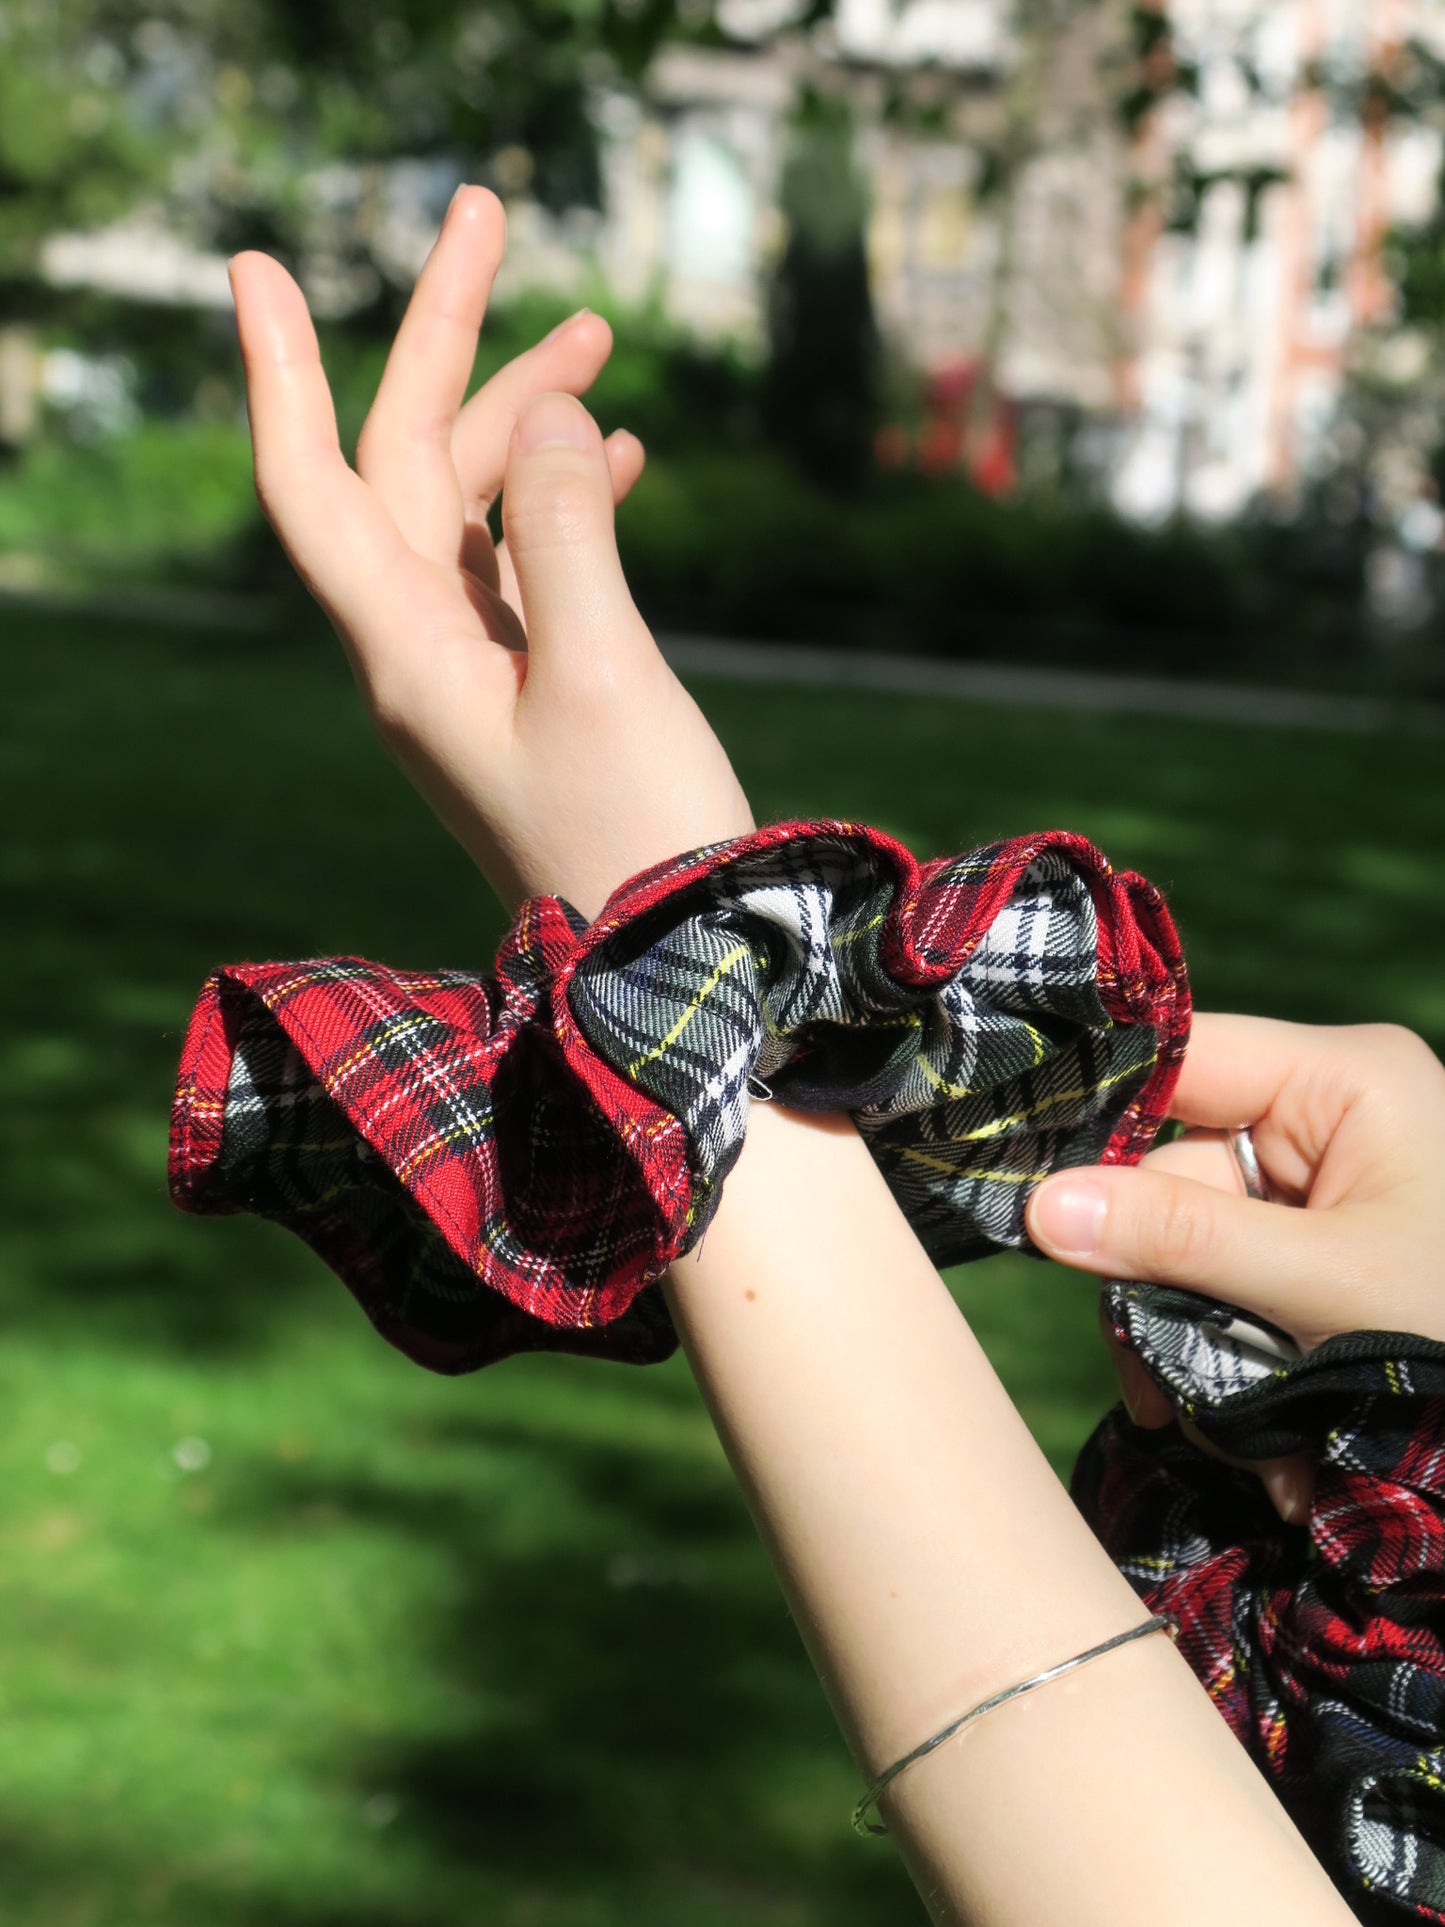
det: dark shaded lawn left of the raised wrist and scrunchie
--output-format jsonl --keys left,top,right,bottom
{"left": 0, "top": 613, "right": 503, "bottom": 1355}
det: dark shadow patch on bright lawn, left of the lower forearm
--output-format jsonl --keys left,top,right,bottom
{"left": 193, "top": 1410, "right": 917, "bottom": 1927}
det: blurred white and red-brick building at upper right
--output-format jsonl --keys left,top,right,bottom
{"left": 1114, "top": 0, "right": 1445, "bottom": 518}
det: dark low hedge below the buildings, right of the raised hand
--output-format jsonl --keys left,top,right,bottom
{"left": 620, "top": 451, "right": 1376, "bottom": 682}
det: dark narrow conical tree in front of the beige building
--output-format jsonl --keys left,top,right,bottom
{"left": 763, "top": 91, "right": 880, "bottom": 493}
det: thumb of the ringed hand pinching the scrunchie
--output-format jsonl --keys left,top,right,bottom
{"left": 1025, "top": 1166, "right": 1356, "bottom": 1341}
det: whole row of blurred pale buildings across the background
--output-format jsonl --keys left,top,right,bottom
{"left": 14, "top": 0, "right": 1445, "bottom": 535}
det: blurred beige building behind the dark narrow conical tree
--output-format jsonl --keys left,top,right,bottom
{"left": 601, "top": 0, "right": 1127, "bottom": 423}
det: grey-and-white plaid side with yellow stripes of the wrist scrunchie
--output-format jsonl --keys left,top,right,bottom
{"left": 568, "top": 844, "right": 1158, "bottom": 1264}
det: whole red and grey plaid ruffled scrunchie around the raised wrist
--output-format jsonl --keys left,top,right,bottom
{"left": 170, "top": 823, "right": 1189, "bottom": 1372}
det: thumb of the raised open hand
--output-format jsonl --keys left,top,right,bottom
{"left": 501, "top": 395, "right": 647, "bottom": 682}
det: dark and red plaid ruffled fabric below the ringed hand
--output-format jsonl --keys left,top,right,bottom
{"left": 1073, "top": 1283, "right": 1445, "bottom": 1921}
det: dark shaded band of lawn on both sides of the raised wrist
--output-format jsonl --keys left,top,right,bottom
{"left": 0, "top": 613, "right": 1445, "bottom": 1353}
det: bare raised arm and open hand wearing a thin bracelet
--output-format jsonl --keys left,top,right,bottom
{"left": 233, "top": 189, "right": 1347, "bottom": 1927}
